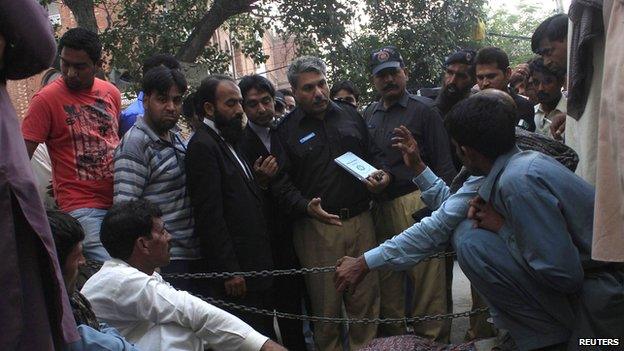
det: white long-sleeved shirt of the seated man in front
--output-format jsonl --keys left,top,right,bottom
{"left": 81, "top": 259, "right": 268, "bottom": 351}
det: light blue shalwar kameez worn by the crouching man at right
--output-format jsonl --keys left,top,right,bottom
{"left": 365, "top": 148, "right": 624, "bottom": 350}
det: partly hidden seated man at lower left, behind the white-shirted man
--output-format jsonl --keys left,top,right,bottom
{"left": 48, "top": 210, "right": 137, "bottom": 351}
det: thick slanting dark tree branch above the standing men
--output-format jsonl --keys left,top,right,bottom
{"left": 176, "top": 0, "right": 257, "bottom": 63}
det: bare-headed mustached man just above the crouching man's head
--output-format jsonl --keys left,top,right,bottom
{"left": 475, "top": 47, "right": 535, "bottom": 132}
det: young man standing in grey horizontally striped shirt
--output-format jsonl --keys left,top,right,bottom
{"left": 113, "top": 66, "right": 201, "bottom": 292}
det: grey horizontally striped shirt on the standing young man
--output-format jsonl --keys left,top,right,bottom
{"left": 113, "top": 117, "right": 201, "bottom": 260}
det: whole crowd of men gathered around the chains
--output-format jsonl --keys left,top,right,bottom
{"left": 0, "top": 1, "right": 624, "bottom": 351}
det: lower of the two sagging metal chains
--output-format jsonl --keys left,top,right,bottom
{"left": 196, "top": 295, "right": 488, "bottom": 324}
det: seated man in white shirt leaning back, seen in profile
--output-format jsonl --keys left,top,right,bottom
{"left": 82, "top": 199, "right": 284, "bottom": 351}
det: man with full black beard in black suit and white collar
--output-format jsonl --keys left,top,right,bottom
{"left": 185, "top": 75, "right": 274, "bottom": 337}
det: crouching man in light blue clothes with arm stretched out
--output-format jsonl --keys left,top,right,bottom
{"left": 337, "top": 95, "right": 624, "bottom": 350}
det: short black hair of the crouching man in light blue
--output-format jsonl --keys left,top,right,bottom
{"left": 444, "top": 95, "right": 517, "bottom": 161}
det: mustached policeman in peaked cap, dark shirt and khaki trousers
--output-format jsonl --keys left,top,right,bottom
{"left": 364, "top": 46, "right": 457, "bottom": 342}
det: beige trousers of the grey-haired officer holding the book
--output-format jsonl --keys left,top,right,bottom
{"left": 293, "top": 211, "right": 379, "bottom": 351}
